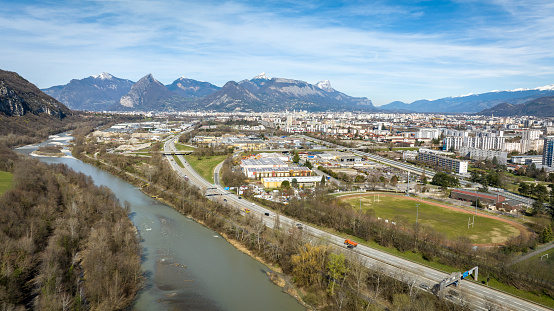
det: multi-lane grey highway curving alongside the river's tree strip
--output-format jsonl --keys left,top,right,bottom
{"left": 164, "top": 133, "right": 550, "bottom": 311}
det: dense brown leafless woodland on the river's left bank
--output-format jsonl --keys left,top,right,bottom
{"left": 0, "top": 147, "right": 142, "bottom": 310}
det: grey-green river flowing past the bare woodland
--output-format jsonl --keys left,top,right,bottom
{"left": 17, "top": 134, "right": 305, "bottom": 311}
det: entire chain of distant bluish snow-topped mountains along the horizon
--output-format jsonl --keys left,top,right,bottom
{"left": 40, "top": 73, "right": 554, "bottom": 113}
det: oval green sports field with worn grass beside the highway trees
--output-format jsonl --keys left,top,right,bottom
{"left": 340, "top": 194, "right": 519, "bottom": 244}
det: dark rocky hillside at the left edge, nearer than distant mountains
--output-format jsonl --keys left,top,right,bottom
{"left": 0, "top": 69, "right": 72, "bottom": 119}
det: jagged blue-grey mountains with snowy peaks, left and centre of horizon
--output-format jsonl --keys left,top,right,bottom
{"left": 44, "top": 73, "right": 376, "bottom": 112}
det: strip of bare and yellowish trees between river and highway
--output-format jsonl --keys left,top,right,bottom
{"left": 74, "top": 130, "right": 488, "bottom": 310}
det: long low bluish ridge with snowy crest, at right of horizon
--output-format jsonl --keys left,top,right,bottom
{"left": 379, "top": 84, "right": 554, "bottom": 113}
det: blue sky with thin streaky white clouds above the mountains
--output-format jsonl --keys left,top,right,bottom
{"left": 0, "top": 0, "right": 554, "bottom": 106}
